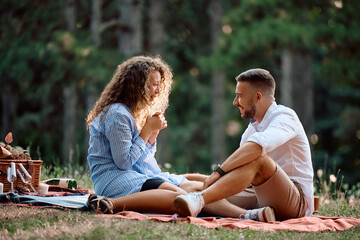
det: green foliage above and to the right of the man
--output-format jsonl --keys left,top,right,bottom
{"left": 214, "top": 0, "right": 360, "bottom": 183}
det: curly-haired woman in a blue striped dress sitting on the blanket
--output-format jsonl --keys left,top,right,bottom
{"left": 86, "top": 56, "right": 245, "bottom": 217}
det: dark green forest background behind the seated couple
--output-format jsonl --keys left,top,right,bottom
{"left": 0, "top": 0, "right": 360, "bottom": 187}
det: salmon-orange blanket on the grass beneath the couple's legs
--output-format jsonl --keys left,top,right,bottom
{"left": 98, "top": 211, "right": 360, "bottom": 232}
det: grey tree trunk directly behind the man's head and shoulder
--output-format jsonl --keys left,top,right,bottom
{"left": 280, "top": 49, "right": 314, "bottom": 138}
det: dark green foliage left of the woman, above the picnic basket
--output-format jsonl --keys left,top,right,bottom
{"left": 0, "top": 1, "right": 122, "bottom": 163}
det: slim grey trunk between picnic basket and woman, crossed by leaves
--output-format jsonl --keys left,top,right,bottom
{"left": 63, "top": 0, "right": 77, "bottom": 166}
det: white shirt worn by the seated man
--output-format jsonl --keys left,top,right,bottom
{"left": 240, "top": 102, "right": 314, "bottom": 216}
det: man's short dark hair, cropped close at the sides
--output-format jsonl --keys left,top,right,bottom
{"left": 235, "top": 68, "right": 276, "bottom": 95}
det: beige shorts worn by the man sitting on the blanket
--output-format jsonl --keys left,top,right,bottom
{"left": 227, "top": 165, "right": 307, "bottom": 221}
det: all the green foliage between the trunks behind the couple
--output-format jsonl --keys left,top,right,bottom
{"left": 0, "top": 0, "right": 360, "bottom": 184}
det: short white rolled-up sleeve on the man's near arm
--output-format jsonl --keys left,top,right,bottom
{"left": 247, "top": 115, "right": 297, "bottom": 156}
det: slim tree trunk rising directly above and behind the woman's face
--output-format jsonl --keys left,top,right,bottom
{"left": 148, "top": 0, "right": 170, "bottom": 166}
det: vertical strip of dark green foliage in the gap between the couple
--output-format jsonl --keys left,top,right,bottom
{"left": 165, "top": 0, "right": 215, "bottom": 173}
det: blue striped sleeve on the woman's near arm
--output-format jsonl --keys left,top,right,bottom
{"left": 105, "top": 112, "right": 145, "bottom": 170}
